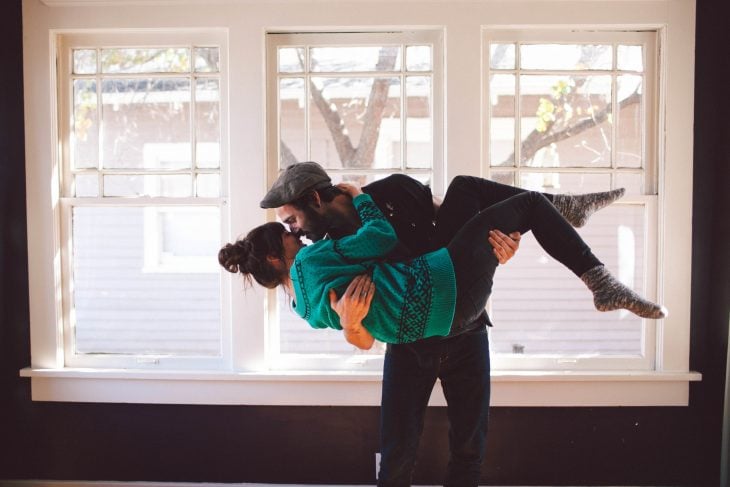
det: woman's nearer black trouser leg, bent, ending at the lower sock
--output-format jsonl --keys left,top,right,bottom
{"left": 446, "top": 187, "right": 601, "bottom": 327}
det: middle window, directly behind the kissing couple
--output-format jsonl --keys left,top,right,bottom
{"left": 267, "top": 31, "right": 443, "bottom": 370}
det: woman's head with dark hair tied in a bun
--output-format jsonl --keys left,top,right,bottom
{"left": 218, "top": 222, "right": 289, "bottom": 289}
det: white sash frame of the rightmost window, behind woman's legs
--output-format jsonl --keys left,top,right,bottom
{"left": 482, "top": 28, "right": 661, "bottom": 372}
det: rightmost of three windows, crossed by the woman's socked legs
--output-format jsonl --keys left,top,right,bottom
{"left": 485, "top": 29, "right": 659, "bottom": 370}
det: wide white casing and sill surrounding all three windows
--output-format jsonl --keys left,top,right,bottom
{"left": 21, "top": 0, "right": 700, "bottom": 406}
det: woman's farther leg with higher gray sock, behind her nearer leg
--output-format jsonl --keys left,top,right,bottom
{"left": 434, "top": 176, "right": 624, "bottom": 248}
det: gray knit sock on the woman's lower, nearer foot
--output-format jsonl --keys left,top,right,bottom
{"left": 580, "top": 265, "right": 669, "bottom": 320}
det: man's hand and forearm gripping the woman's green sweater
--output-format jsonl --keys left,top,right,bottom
{"left": 329, "top": 275, "right": 375, "bottom": 350}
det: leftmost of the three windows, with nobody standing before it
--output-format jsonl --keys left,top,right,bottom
{"left": 58, "top": 34, "right": 229, "bottom": 368}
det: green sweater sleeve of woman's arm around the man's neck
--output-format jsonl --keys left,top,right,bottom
{"left": 334, "top": 194, "right": 398, "bottom": 260}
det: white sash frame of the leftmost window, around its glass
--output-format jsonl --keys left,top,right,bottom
{"left": 52, "top": 30, "right": 231, "bottom": 370}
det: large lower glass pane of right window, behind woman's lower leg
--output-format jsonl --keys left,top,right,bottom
{"left": 490, "top": 205, "right": 646, "bottom": 356}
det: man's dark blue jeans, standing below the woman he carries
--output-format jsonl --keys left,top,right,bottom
{"left": 378, "top": 327, "right": 490, "bottom": 487}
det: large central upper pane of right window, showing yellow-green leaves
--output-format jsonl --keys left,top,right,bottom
{"left": 520, "top": 75, "right": 611, "bottom": 167}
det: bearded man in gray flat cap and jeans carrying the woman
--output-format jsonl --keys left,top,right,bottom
{"left": 261, "top": 162, "right": 519, "bottom": 486}
